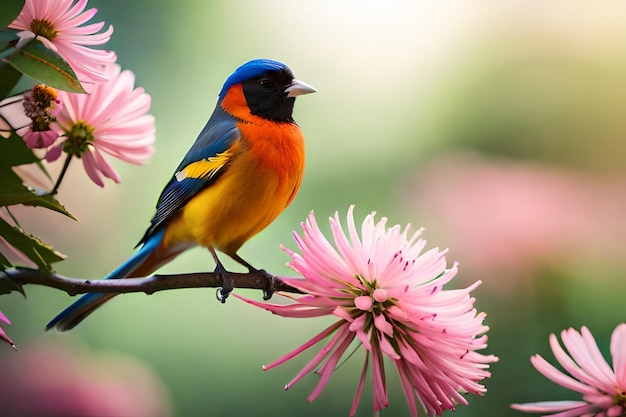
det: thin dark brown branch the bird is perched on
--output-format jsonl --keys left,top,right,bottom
{"left": 0, "top": 268, "right": 301, "bottom": 295}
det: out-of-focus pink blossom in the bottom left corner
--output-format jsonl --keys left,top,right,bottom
{"left": 0, "top": 339, "right": 173, "bottom": 417}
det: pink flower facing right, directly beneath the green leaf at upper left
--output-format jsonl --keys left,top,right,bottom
{"left": 46, "top": 64, "right": 155, "bottom": 187}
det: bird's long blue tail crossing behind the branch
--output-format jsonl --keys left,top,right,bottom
{"left": 46, "top": 228, "right": 165, "bottom": 331}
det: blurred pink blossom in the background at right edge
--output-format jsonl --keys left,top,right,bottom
{"left": 402, "top": 153, "right": 626, "bottom": 291}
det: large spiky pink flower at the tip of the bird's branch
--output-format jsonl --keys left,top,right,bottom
{"left": 238, "top": 207, "right": 497, "bottom": 416}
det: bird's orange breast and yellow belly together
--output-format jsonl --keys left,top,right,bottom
{"left": 168, "top": 109, "right": 304, "bottom": 254}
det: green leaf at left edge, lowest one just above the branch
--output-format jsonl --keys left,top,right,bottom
{"left": 0, "top": 214, "right": 65, "bottom": 271}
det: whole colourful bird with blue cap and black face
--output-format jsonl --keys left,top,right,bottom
{"left": 46, "top": 59, "right": 316, "bottom": 331}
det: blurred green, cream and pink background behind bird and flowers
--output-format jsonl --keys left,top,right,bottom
{"left": 0, "top": 0, "right": 626, "bottom": 416}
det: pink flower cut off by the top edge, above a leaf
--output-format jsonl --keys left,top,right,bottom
{"left": 9, "top": 0, "right": 117, "bottom": 83}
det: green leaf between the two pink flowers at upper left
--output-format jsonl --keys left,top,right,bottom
{"left": 4, "top": 40, "right": 85, "bottom": 93}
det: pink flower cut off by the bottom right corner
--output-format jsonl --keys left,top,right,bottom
{"left": 511, "top": 323, "right": 626, "bottom": 417}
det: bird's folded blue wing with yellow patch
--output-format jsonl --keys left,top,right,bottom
{"left": 138, "top": 102, "right": 240, "bottom": 245}
